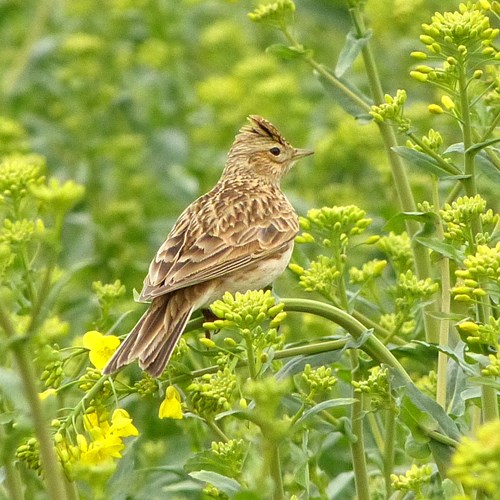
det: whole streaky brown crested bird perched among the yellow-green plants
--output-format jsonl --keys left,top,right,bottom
{"left": 103, "top": 115, "right": 313, "bottom": 377}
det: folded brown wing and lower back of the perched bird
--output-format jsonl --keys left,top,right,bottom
{"left": 140, "top": 190, "right": 299, "bottom": 300}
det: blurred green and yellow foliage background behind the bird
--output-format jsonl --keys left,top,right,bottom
{"left": 0, "top": 0, "right": 500, "bottom": 498}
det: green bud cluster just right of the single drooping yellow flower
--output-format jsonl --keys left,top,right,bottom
{"left": 186, "top": 367, "right": 236, "bottom": 420}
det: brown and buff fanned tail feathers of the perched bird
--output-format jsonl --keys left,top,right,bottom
{"left": 103, "top": 291, "right": 193, "bottom": 377}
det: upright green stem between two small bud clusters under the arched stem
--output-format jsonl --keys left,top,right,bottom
{"left": 349, "top": 349, "right": 370, "bottom": 500}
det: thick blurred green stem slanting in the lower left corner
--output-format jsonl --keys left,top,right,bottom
{"left": 0, "top": 300, "right": 67, "bottom": 500}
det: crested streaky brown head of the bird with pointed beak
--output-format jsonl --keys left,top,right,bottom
{"left": 224, "top": 115, "right": 313, "bottom": 183}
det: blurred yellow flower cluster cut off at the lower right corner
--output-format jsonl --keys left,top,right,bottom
{"left": 449, "top": 420, "right": 500, "bottom": 498}
